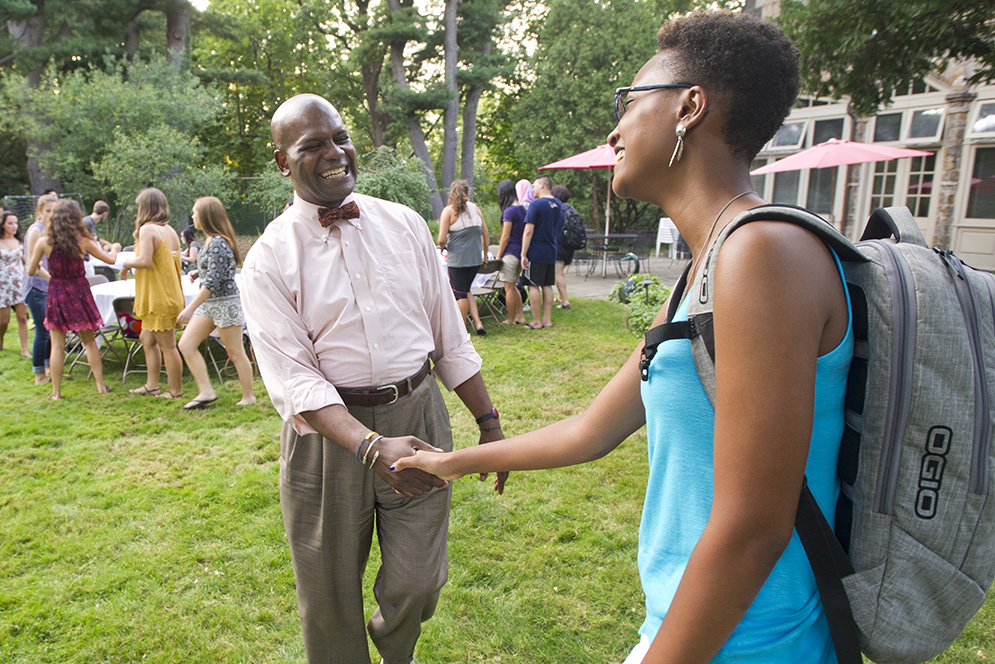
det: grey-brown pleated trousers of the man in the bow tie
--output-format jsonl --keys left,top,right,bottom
{"left": 280, "top": 377, "right": 453, "bottom": 664}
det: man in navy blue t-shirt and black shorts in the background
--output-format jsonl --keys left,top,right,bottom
{"left": 522, "top": 175, "right": 563, "bottom": 330}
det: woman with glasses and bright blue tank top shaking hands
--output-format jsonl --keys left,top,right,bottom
{"left": 395, "top": 12, "right": 853, "bottom": 664}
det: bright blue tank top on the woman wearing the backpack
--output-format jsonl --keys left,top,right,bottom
{"left": 638, "top": 254, "right": 853, "bottom": 664}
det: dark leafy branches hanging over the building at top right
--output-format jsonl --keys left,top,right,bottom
{"left": 779, "top": 0, "right": 995, "bottom": 116}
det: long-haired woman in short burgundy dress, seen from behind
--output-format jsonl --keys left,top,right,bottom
{"left": 28, "top": 199, "right": 121, "bottom": 399}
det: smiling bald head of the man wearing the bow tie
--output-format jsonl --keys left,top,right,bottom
{"left": 273, "top": 97, "right": 356, "bottom": 207}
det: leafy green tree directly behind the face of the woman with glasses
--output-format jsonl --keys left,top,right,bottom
{"left": 483, "top": 0, "right": 662, "bottom": 230}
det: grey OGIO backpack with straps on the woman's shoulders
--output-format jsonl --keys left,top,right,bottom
{"left": 641, "top": 205, "right": 995, "bottom": 664}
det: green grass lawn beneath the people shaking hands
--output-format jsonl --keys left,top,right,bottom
{"left": 0, "top": 299, "right": 995, "bottom": 664}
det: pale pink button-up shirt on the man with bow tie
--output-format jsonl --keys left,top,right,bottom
{"left": 241, "top": 194, "right": 481, "bottom": 434}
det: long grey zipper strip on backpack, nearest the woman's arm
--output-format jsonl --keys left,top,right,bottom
{"left": 870, "top": 240, "right": 916, "bottom": 515}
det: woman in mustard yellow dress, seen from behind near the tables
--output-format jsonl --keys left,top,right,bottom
{"left": 124, "top": 187, "right": 185, "bottom": 399}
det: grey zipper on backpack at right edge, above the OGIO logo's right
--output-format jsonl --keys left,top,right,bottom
{"left": 939, "top": 251, "right": 992, "bottom": 496}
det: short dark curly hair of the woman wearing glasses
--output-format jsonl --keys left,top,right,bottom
{"left": 656, "top": 11, "right": 799, "bottom": 160}
